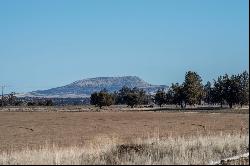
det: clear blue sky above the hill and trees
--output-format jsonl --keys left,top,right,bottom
{"left": 0, "top": 0, "right": 249, "bottom": 92}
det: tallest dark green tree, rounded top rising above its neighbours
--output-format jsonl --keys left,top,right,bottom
{"left": 183, "top": 71, "right": 203, "bottom": 105}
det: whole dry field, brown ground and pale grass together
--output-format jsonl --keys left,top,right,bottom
{"left": 0, "top": 108, "right": 249, "bottom": 164}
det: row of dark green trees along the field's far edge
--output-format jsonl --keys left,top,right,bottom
{"left": 90, "top": 71, "right": 249, "bottom": 108}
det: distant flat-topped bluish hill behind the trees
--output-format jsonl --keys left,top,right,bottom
{"left": 18, "top": 76, "right": 167, "bottom": 98}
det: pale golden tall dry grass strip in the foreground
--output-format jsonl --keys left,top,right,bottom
{"left": 0, "top": 134, "right": 249, "bottom": 165}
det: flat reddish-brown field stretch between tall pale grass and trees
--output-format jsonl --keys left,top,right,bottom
{"left": 0, "top": 109, "right": 249, "bottom": 152}
